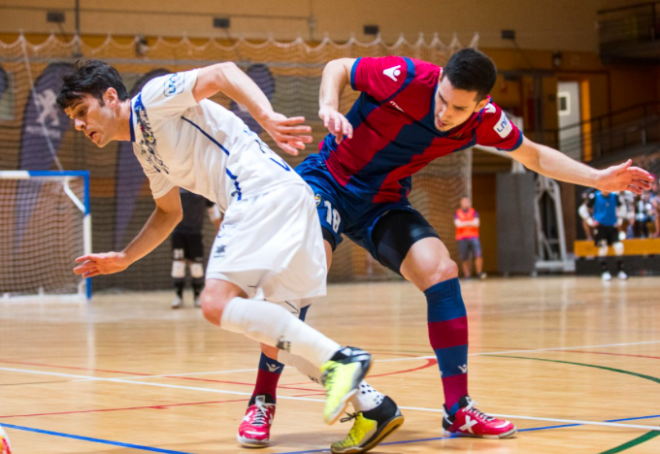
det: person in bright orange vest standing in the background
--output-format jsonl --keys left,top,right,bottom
{"left": 454, "top": 197, "right": 486, "bottom": 279}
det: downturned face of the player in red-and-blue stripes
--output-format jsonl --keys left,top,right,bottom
{"left": 435, "top": 77, "right": 488, "bottom": 132}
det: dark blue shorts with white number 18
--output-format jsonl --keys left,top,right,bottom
{"left": 296, "top": 154, "right": 417, "bottom": 260}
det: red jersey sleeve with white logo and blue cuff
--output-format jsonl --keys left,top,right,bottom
{"left": 351, "top": 56, "right": 415, "bottom": 102}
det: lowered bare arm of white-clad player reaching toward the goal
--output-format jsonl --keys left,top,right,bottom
{"left": 73, "top": 187, "right": 183, "bottom": 277}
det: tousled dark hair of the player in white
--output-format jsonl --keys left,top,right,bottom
{"left": 57, "top": 60, "right": 130, "bottom": 110}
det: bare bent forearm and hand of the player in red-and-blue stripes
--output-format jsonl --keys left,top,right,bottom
{"left": 319, "top": 58, "right": 355, "bottom": 143}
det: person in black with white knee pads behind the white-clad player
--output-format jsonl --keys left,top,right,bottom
{"left": 172, "top": 188, "right": 221, "bottom": 309}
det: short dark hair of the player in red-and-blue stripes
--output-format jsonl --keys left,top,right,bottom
{"left": 442, "top": 49, "right": 497, "bottom": 101}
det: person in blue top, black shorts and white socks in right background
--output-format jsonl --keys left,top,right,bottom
{"left": 588, "top": 191, "right": 628, "bottom": 281}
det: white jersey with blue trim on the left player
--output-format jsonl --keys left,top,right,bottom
{"left": 131, "top": 70, "right": 305, "bottom": 212}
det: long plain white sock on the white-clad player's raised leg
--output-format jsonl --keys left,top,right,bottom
{"left": 220, "top": 298, "right": 340, "bottom": 368}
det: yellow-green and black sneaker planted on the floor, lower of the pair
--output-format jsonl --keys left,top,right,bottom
{"left": 330, "top": 396, "right": 404, "bottom": 454}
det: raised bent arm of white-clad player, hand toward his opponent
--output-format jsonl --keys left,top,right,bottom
{"left": 193, "top": 62, "right": 312, "bottom": 156}
